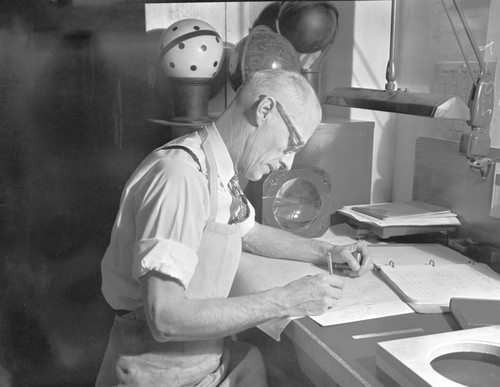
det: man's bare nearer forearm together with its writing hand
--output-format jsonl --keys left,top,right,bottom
{"left": 143, "top": 273, "right": 343, "bottom": 341}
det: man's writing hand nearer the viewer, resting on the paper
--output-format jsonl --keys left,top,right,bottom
{"left": 276, "top": 274, "right": 344, "bottom": 317}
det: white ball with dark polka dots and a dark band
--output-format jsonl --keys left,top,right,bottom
{"left": 158, "top": 19, "right": 224, "bottom": 78}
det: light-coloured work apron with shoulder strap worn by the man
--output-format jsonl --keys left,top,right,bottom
{"left": 96, "top": 130, "right": 267, "bottom": 387}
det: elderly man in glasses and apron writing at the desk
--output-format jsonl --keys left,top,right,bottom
{"left": 96, "top": 70, "right": 372, "bottom": 387}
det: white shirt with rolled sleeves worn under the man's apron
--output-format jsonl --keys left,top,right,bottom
{"left": 101, "top": 125, "right": 255, "bottom": 310}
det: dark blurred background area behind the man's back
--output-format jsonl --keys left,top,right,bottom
{"left": 0, "top": 0, "right": 175, "bottom": 386}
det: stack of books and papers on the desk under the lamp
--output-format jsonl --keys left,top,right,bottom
{"left": 338, "top": 201, "right": 460, "bottom": 239}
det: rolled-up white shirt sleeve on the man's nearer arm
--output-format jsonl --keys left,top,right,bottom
{"left": 132, "top": 156, "right": 210, "bottom": 288}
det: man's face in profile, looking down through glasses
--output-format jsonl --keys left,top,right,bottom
{"left": 238, "top": 101, "right": 315, "bottom": 181}
